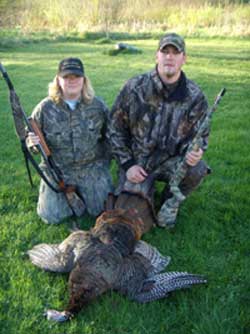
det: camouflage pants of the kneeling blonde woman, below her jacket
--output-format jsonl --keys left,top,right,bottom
{"left": 37, "top": 161, "right": 113, "bottom": 224}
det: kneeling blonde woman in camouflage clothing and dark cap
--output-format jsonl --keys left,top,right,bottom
{"left": 27, "top": 58, "right": 112, "bottom": 223}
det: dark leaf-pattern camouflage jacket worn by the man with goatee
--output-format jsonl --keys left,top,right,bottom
{"left": 109, "top": 69, "right": 209, "bottom": 172}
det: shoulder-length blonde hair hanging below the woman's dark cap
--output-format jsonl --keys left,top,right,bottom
{"left": 48, "top": 75, "right": 95, "bottom": 104}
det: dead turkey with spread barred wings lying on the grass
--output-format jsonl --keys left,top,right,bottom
{"left": 28, "top": 192, "right": 206, "bottom": 322}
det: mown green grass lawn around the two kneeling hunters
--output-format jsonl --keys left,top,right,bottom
{"left": 0, "top": 38, "right": 250, "bottom": 334}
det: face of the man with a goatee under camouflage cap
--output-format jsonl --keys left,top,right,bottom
{"left": 156, "top": 45, "right": 186, "bottom": 83}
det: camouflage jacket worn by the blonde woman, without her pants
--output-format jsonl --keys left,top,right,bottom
{"left": 31, "top": 97, "right": 110, "bottom": 170}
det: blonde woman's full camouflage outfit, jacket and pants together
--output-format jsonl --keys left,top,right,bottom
{"left": 32, "top": 98, "right": 112, "bottom": 223}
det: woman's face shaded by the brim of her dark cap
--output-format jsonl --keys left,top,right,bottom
{"left": 58, "top": 74, "right": 84, "bottom": 100}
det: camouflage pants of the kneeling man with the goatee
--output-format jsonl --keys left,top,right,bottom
{"left": 116, "top": 157, "right": 209, "bottom": 201}
